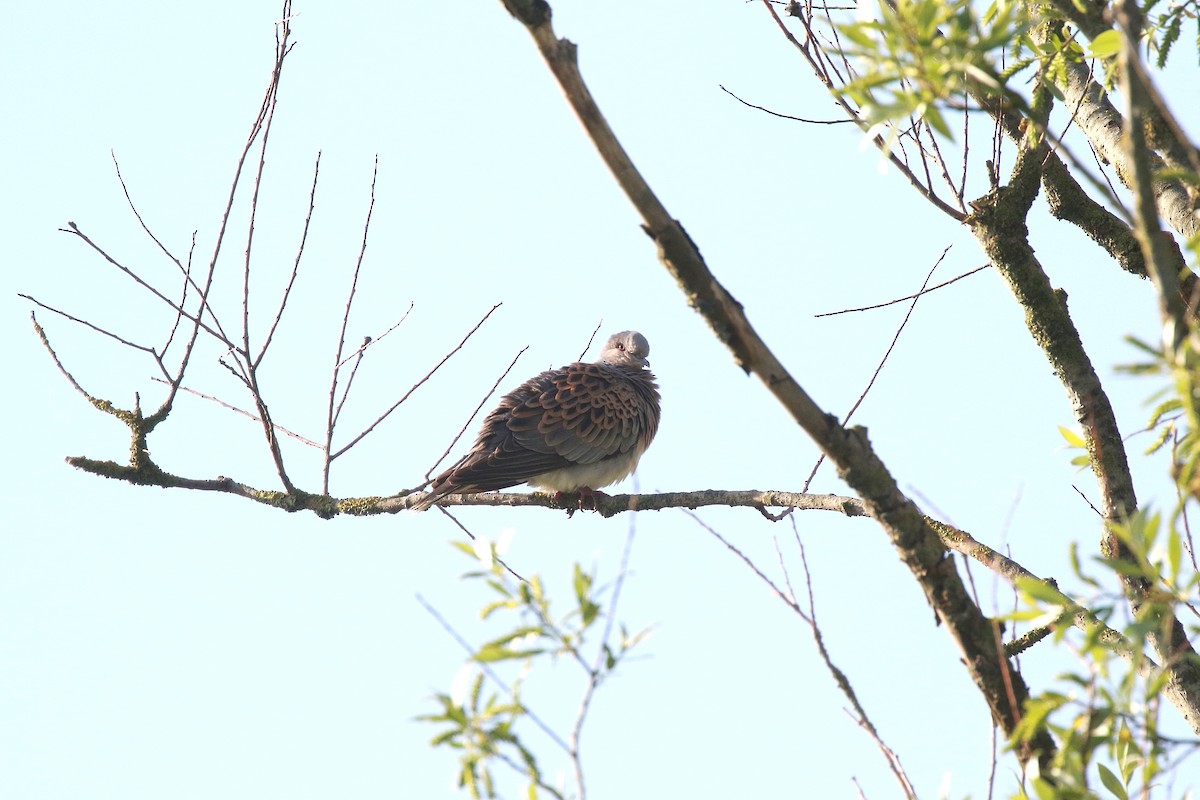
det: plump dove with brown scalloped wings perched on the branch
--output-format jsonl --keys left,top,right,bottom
{"left": 413, "top": 331, "right": 659, "bottom": 511}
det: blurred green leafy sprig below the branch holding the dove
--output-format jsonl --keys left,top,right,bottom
{"left": 418, "top": 539, "right": 649, "bottom": 800}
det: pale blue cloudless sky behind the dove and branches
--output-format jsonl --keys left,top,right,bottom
{"left": 0, "top": 0, "right": 1200, "bottom": 800}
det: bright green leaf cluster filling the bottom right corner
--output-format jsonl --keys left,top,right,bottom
{"left": 1010, "top": 512, "right": 1200, "bottom": 800}
